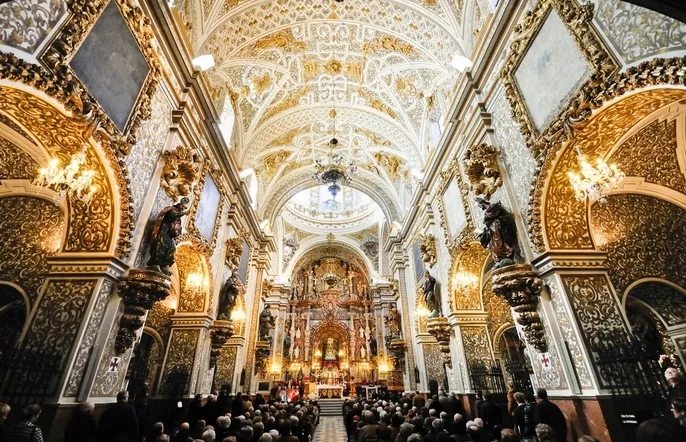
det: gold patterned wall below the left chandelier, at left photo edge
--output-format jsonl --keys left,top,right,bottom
{"left": 0, "top": 197, "right": 65, "bottom": 307}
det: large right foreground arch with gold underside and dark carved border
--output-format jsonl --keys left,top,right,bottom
{"left": 527, "top": 58, "right": 686, "bottom": 252}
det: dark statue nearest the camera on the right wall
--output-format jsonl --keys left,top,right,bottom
{"left": 476, "top": 198, "right": 519, "bottom": 270}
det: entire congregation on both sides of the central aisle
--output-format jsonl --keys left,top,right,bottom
{"left": 0, "top": 370, "right": 686, "bottom": 442}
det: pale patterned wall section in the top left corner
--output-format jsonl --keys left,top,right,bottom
{"left": 0, "top": 0, "right": 67, "bottom": 54}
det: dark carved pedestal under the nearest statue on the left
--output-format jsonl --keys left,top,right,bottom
{"left": 114, "top": 269, "right": 171, "bottom": 354}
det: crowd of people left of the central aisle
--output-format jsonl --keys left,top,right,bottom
{"left": 0, "top": 391, "right": 319, "bottom": 442}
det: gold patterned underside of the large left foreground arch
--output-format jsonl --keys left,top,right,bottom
{"left": 0, "top": 81, "right": 133, "bottom": 257}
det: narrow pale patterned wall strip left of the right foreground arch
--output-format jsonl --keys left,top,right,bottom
{"left": 491, "top": 88, "right": 536, "bottom": 218}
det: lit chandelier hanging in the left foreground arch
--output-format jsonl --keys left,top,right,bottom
{"left": 33, "top": 143, "right": 96, "bottom": 204}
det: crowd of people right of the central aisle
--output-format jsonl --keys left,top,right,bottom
{"left": 343, "top": 388, "right": 686, "bottom": 442}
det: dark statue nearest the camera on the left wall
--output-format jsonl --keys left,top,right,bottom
{"left": 148, "top": 198, "right": 190, "bottom": 275}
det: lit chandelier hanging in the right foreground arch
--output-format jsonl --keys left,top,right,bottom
{"left": 567, "top": 147, "right": 626, "bottom": 203}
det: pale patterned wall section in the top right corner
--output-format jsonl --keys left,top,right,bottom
{"left": 595, "top": 0, "right": 686, "bottom": 64}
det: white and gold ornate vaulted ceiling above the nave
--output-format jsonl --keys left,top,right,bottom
{"left": 176, "top": 0, "right": 478, "bottom": 221}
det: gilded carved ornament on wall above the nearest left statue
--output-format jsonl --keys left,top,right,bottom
{"left": 160, "top": 146, "right": 202, "bottom": 201}
